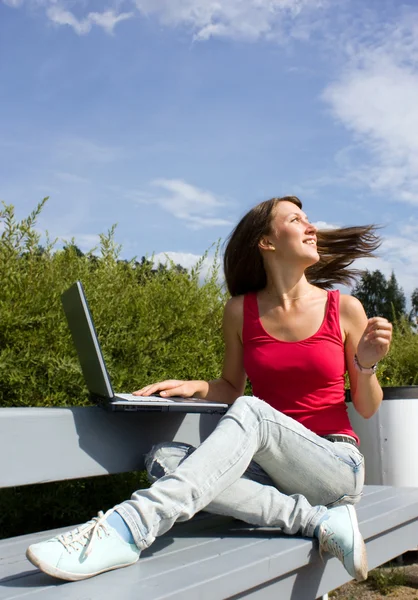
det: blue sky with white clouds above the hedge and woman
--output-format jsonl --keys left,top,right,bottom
{"left": 0, "top": 0, "right": 418, "bottom": 294}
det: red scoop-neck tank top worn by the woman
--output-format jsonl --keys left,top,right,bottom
{"left": 242, "top": 290, "right": 359, "bottom": 441}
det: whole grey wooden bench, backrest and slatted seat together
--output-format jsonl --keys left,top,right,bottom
{"left": 0, "top": 407, "right": 418, "bottom": 600}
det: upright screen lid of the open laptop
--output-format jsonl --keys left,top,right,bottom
{"left": 61, "top": 281, "right": 114, "bottom": 399}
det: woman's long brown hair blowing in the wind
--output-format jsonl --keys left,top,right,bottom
{"left": 224, "top": 196, "right": 381, "bottom": 296}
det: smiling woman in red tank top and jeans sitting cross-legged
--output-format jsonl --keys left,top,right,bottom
{"left": 27, "top": 196, "right": 392, "bottom": 580}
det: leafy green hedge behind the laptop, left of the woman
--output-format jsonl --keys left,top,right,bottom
{"left": 0, "top": 200, "right": 225, "bottom": 406}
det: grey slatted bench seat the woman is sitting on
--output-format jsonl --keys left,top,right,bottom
{"left": 0, "top": 486, "right": 418, "bottom": 600}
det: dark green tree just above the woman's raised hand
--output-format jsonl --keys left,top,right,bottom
{"left": 351, "top": 270, "right": 406, "bottom": 321}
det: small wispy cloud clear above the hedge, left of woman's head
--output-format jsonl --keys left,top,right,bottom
{"left": 136, "top": 179, "right": 234, "bottom": 229}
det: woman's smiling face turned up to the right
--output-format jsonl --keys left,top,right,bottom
{"left": 264, "top": 200, "right": 319, "bottom": 265}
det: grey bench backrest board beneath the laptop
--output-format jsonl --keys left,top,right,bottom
{"left": 0, "top": 407, "right": 220, "bottom": 487}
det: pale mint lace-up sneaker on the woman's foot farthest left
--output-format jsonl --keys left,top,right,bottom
{"left": 26, "top": 508, "right": 141, "bottom": 581}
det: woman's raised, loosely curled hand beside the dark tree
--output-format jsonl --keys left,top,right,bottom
{"left": 357, "top": 317, "right": 392, "bottom": 368}
